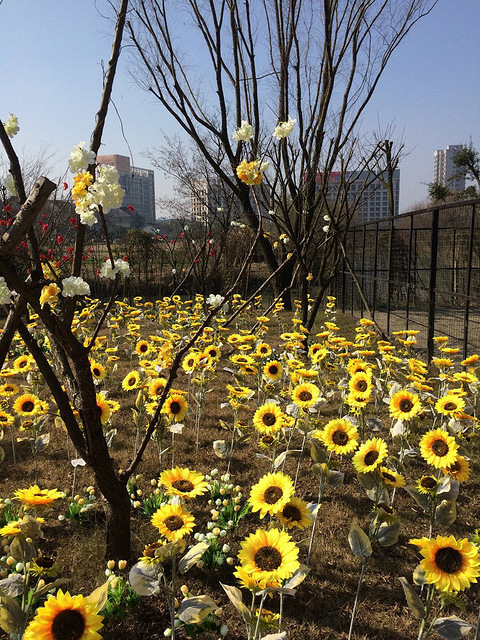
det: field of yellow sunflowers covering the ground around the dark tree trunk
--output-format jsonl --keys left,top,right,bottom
{"left": 0, "top": 295, "right": 480, "bottom": 640}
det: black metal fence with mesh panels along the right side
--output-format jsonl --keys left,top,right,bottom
{"left": 334, "top": 200, "right": 480, "bottom": 358}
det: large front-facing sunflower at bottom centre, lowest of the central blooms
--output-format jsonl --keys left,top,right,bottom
{"left": 238, "top": 529, "right": 300, "bottom": 581}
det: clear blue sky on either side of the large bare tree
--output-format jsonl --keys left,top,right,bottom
{"left": 0, "top": 0, "right": 480, "bottom": 215}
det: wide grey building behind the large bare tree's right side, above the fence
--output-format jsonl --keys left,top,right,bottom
{"left": 317, "top": 169, "right": 400, "bottom": 222}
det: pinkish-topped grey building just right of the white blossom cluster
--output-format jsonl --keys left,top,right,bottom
{"left": 97, "top": 155, "right": 155, "bottom": 227}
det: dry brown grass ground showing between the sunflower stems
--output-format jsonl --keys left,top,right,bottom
{"left": 0, "top": 310, "right": 480, "bottom": 640}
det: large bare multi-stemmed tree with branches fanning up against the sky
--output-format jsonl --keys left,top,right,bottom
{"left": 128, "top": 0, "right": 436, "bottom": 326}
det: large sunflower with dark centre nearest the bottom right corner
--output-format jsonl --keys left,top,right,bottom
{"left": 410, "top": 536, "right": 480, "bottom": 591}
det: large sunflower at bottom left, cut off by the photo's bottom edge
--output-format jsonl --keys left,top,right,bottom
{"left": 23, "top": 589, "right": 103, "bottom": 640}
